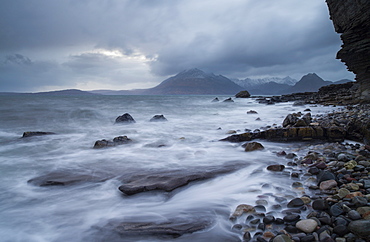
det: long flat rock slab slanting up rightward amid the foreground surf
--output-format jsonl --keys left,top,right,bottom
{"left": 119, "top": 163, "right": 245, "bottom": 195}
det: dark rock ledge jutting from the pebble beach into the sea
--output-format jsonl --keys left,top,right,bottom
{"left": 221, "top": 105, "right": 370, "bottom": 144}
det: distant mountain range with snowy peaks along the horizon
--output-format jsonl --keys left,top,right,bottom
{"left": 0, "top": 68, "right": 351, "bottom": 95}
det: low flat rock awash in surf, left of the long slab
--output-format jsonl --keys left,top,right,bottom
{"left": 28, "top": 170, "right": 114, "bottom": 187}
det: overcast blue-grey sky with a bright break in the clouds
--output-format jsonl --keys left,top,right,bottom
{"left": 0, "top": 0, "right": 354, "bottom": 92}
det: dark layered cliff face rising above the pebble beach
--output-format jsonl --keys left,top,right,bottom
{"left": 326, "top": 0, "right": 370, "bottom": 102}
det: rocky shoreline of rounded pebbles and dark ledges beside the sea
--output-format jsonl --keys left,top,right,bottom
{"left": 221, "top": 96, "right": 370, "bottom": 242}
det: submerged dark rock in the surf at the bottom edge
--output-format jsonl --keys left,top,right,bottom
{"left": 102, "top": 215, "right": 214, "bottom": 238}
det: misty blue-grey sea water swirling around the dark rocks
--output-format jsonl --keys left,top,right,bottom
{"left": 0, "top": 95, "right": 333, "bottom": 241}
